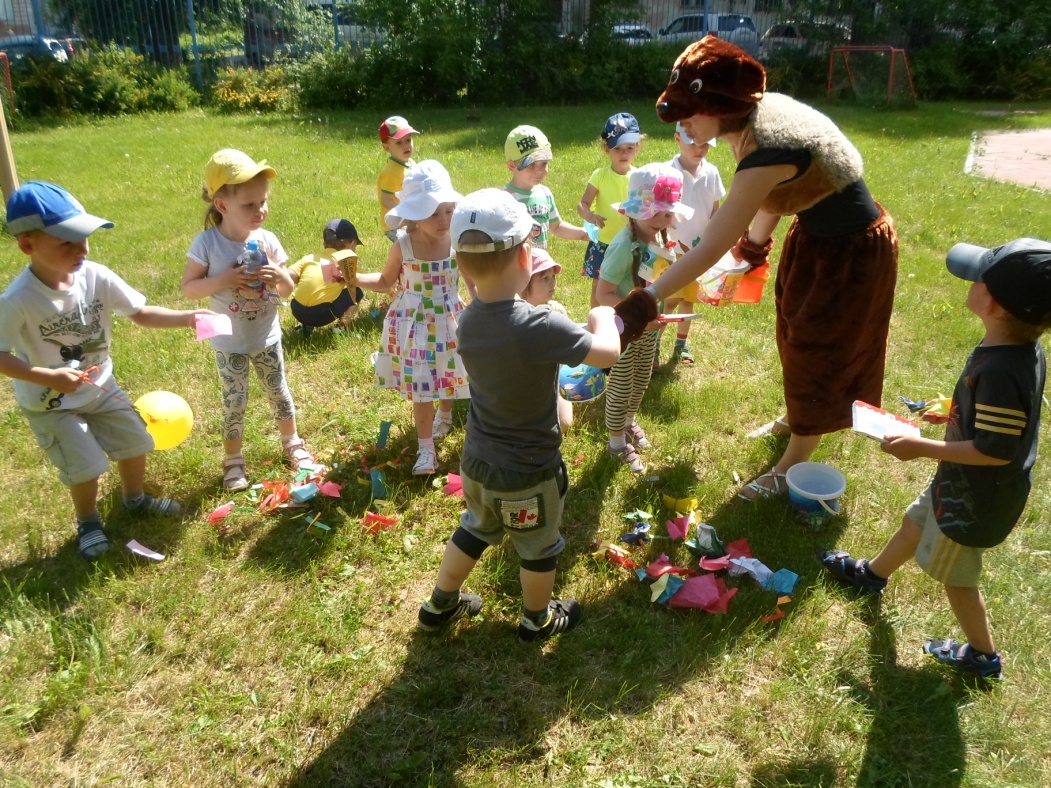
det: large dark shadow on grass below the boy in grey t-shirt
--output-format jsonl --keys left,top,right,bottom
{"left": 287, "top": 586, "right": 765, "bottom": 788}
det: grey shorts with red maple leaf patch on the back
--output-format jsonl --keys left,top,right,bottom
{"left": 460, "top": 457, "right": 570, "bottom": 561}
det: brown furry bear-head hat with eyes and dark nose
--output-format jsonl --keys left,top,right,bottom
{"left": 657, "top": 36, "right": 766, "bottom": 123}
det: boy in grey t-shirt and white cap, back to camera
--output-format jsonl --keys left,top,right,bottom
{"left": 419, "top": 189, "right": 620, "bottom": 642}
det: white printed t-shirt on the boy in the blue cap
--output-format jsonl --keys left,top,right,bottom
{"left": 0, "top": 261, "right": 146, "bottom": 411}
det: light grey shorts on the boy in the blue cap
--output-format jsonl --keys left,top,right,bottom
{"left": 23, "top": 385, "right": 153, "bottom": 486}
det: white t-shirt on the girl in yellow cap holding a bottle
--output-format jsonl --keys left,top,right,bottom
{"left": 186, "top": 227, "right": 288, "bottom": 353}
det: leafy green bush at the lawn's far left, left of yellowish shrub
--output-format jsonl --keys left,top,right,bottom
{"left": 12, "top": 46, "right": 199, "bottom": 118}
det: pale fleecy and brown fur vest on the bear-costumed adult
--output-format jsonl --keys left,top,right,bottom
{"left": 750, "top": 94, "right": 863, "bottom": 215}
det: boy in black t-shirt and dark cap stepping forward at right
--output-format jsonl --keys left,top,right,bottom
{"left": 821, "top": 239, "right": 1051, "bottom": 679}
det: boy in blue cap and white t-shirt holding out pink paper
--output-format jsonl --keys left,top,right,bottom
{"left": 0, "top": 181, "right": 212, "bottom": 559}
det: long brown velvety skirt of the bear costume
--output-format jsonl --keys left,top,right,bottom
{"left": 774, "top": 206, "right": 898, "bottom": 435}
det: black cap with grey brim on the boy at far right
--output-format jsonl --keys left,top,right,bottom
{"left": 945, "top": 239, "right": 1051, "bottom": 326}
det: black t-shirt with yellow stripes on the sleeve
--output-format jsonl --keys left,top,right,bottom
{"left": 931, "top": 341, "right": 1047, "bottom": 547}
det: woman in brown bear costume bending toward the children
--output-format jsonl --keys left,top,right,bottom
{"left": 617, "top": 36, "right": 898, "bottom": 498}
